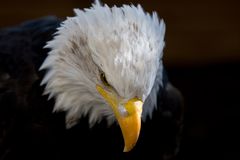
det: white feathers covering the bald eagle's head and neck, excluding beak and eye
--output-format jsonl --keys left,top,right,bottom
{"left": 40, "top": 1, "right": 165, "bottom": 127}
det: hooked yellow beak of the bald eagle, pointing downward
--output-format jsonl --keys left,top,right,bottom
{"left": 96, "top": 85, "right": 143, "bottom": 152}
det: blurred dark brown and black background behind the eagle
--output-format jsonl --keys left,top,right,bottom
{"left": 0, "top": 0, "right": 240, "bottom": 159}
